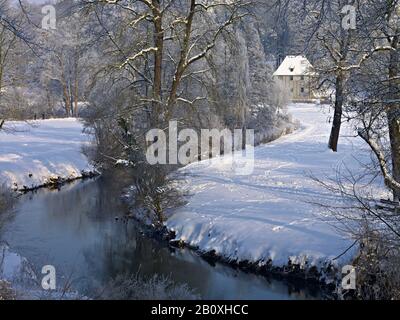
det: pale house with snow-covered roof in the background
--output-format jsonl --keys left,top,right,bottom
{"left": 273, "top": 56, "right": 316, "bottom": 101}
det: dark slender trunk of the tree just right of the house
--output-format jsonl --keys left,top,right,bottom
{"left": 329, "top": 72, "right": 344, "bottom": 152}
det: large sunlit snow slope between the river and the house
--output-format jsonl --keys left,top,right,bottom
{"left": 166, "top": 104, "right": 384, "bottom": 274}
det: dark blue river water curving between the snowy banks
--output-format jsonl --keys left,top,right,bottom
{"left": 2, "top": 178, "right": 318, "bottom": 299}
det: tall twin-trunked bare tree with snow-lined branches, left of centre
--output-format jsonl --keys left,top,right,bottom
{"left": 88, "top": 0, "right": 247, "bottom": 124}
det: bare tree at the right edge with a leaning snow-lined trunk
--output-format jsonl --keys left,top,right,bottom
{"left": 347, "top": 0, "right": 400, "bottom": 201}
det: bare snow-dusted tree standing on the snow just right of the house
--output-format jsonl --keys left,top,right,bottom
{"left": 298, "top": 0, "right": 363, "bottom": 152}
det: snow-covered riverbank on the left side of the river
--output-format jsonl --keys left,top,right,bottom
{"left": 0, "top": 118, "right": 93, "bottom": 189}
